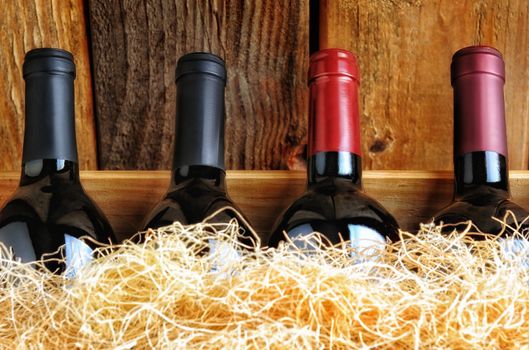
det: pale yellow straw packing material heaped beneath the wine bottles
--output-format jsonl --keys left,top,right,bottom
{"left": 0, "top": 222, "right": 529, "bottom": 349}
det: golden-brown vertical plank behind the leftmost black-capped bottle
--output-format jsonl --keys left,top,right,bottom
{"left": 0, "top": 0, "right": 97, "bottom": 171}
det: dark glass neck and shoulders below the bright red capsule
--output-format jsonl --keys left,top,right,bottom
{"left": 269, "top": 152, "right": 398, "bottom": 249}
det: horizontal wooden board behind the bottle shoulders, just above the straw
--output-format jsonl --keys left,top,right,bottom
{"left": 0, "top": 170, "right": 529, "bottom": 238}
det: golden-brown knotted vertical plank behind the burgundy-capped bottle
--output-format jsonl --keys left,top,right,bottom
{"left": 320, "top": 0, "right": 529, "bottom": 169}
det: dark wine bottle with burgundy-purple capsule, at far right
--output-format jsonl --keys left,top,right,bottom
{"left": 434, "top": 46, "right": 528, "bottom": 234}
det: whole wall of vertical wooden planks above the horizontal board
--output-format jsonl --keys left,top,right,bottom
{"left": 0, "top": 0, "right": 529, "bottom": 171}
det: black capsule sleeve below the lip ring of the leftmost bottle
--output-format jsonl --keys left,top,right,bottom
{"left": 22, "top": 71, "right": 78, "bottom": 164}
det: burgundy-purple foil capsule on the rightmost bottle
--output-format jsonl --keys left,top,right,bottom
{"left": 451, "top": 46, "right": 507, "bottom": 157}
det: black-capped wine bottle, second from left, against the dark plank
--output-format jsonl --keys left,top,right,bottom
{"left": 143, "top": 52, "right": 251, "bottom": 244}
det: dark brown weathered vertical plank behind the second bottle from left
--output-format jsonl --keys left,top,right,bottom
{"left": 89, "top": 0, "right": 309, "bottom": 169}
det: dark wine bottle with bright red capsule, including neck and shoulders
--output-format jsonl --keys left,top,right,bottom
{"left": 268, "top": 49, "right": 398, "bottom": 248}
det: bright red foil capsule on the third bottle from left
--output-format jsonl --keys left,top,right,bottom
{"left": 308, "top": 49, "right": 361, "bottom": 156}
